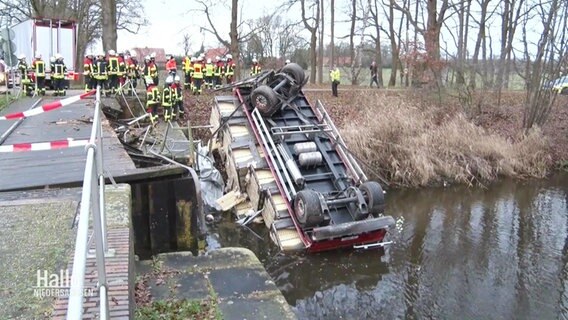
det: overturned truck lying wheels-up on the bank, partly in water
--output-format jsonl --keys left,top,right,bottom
{"left": 211, "top": 63, "right": 394, "bottom": 252}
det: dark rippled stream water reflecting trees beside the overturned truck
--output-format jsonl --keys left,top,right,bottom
{"left": 210, "top": 174, "right": 568, "bottom": 319}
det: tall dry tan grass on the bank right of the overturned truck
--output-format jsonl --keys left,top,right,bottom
{"left": 309, "top": 90, "right": 552, "bottom": 187}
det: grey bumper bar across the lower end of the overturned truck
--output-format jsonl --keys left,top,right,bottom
{"left": 312, "top": 216, "right": 395, "bottom": 241}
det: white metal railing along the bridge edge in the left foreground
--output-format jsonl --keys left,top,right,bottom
{"left": 67, "top": 86, "right": 109, "bottom": 320}
